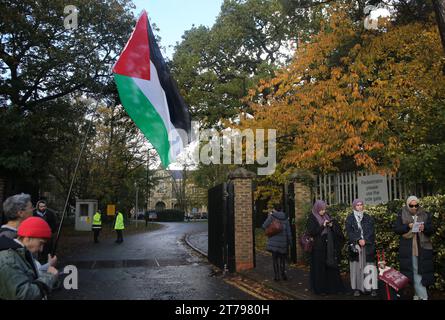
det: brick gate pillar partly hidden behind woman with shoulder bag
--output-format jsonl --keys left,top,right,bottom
{"left": 291, "top": 172, "right": 314, "bottom": 263}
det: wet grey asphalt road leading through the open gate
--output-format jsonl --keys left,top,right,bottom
{"left": 50, "top": 222, "right": 254, "bottom": 300}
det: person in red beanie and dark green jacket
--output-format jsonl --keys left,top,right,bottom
{"left": 0, "top": 217, "right": 58, "bottom": 300}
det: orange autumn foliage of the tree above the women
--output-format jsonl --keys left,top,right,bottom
{"left": 242, "top": 10, "right": 445, "bottom": 172}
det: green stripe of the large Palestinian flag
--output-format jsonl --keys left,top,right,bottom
{"left": 114, "top": 74, "right": 170, "bottom": 167}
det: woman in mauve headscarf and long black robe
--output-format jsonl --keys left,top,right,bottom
{"left": 307, "top": 200, "right": 344, "bottom": 294}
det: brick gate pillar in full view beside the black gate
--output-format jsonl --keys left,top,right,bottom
{"left": 229, "top": 168, "right": 255, "bottom": 272}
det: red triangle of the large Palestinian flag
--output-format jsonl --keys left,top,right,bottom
{"left": 113, "top": 11, "right": 150, "bottom": 80}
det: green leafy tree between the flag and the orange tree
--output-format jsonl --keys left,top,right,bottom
{"left": 171, "top": 0, "right": 297, "bottom": 126}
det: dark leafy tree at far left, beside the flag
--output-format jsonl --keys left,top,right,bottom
{"left": 0, "top": 0, "right": 134, "bottom": 190}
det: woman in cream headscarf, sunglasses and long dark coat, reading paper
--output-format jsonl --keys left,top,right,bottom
{"left": 394, "top": 196, "right": 434, "bottom": 300}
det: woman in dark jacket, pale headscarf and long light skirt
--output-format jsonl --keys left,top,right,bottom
{"left": 346, "top": 199, "right": 378, "bottom": 297}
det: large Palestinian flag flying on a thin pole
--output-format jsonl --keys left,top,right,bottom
{"left": 113, "top": 11, "right": 191, "bottom": 168}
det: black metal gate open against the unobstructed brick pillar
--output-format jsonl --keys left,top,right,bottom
{"left": 208, "top": 183, "right": 235, "bottom": 272}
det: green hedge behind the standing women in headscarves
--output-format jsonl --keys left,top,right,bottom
{"left": 297, "top": 195, "right": 445, "bottom": 290}
